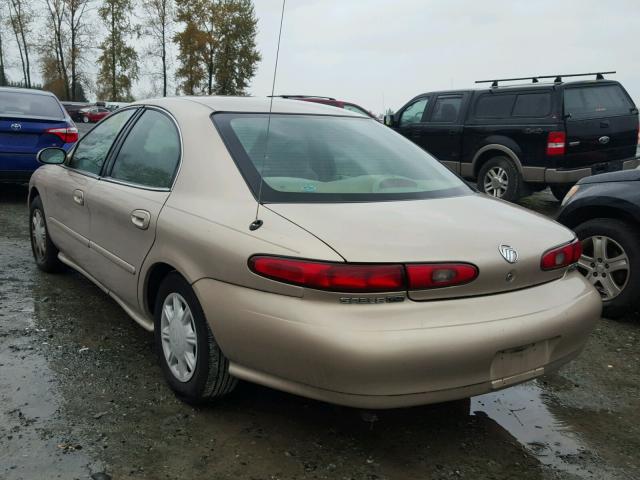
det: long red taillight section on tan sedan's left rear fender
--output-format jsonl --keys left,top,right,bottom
{"left": 249, "top": 256, "right": 406, "bottom": 293}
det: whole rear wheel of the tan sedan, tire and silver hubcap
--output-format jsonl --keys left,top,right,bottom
{"left": 154, "top": 272, "right": 237, "bottom": 404}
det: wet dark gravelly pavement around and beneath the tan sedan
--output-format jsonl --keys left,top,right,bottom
{"left": 0, "top": 185, "right": 640, "bottom": 480}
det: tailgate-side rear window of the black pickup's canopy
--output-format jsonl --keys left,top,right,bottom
{"left": 564, "top": 85, "right": 633, "bottom": 118}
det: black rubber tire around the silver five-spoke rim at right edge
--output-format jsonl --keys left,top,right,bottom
{"left": 574, "top": 218, "right": 640, "bottom": 318}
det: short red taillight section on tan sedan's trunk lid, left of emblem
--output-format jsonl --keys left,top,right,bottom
{"left": 407, "top": 263, "right": 478, "bottom": 290}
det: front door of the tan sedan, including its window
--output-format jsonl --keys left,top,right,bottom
{"left": 45, "top": 109, "right": 135, "bottom": 273}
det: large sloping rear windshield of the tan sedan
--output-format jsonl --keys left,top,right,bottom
{"left": 213, "top": 113, "right": 471, "bottom": 203}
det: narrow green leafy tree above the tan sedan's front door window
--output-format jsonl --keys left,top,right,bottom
{"left": 97, "top": 0, "right": 138, "bottom": 102}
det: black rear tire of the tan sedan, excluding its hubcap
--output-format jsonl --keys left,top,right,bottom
{"left": 154, "top": 272, "right": 238, "bottom": 404}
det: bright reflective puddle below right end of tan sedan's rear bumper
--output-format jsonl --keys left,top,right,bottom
{"left": 470, "top": 382, "right": 594, "bottom": 478}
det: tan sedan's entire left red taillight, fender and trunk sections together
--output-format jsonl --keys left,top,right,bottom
{"left": 249, "top": 255, "right": 478, "bottom": 293}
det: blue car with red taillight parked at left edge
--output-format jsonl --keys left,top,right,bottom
{"left": 0, "top": 87, "right": 78, "bottom": 183}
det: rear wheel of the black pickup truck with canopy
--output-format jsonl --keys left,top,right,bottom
{"left": 478, "top": 157, "right": 524, "bottom": 202}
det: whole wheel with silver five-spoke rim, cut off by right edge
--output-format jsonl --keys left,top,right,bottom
{"left": 574, "top": 218, "right": 640, "bottom": 318}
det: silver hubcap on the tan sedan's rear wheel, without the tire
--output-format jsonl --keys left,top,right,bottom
{"left": 160, "top": 293, "right": 198, "bottom": 383}
